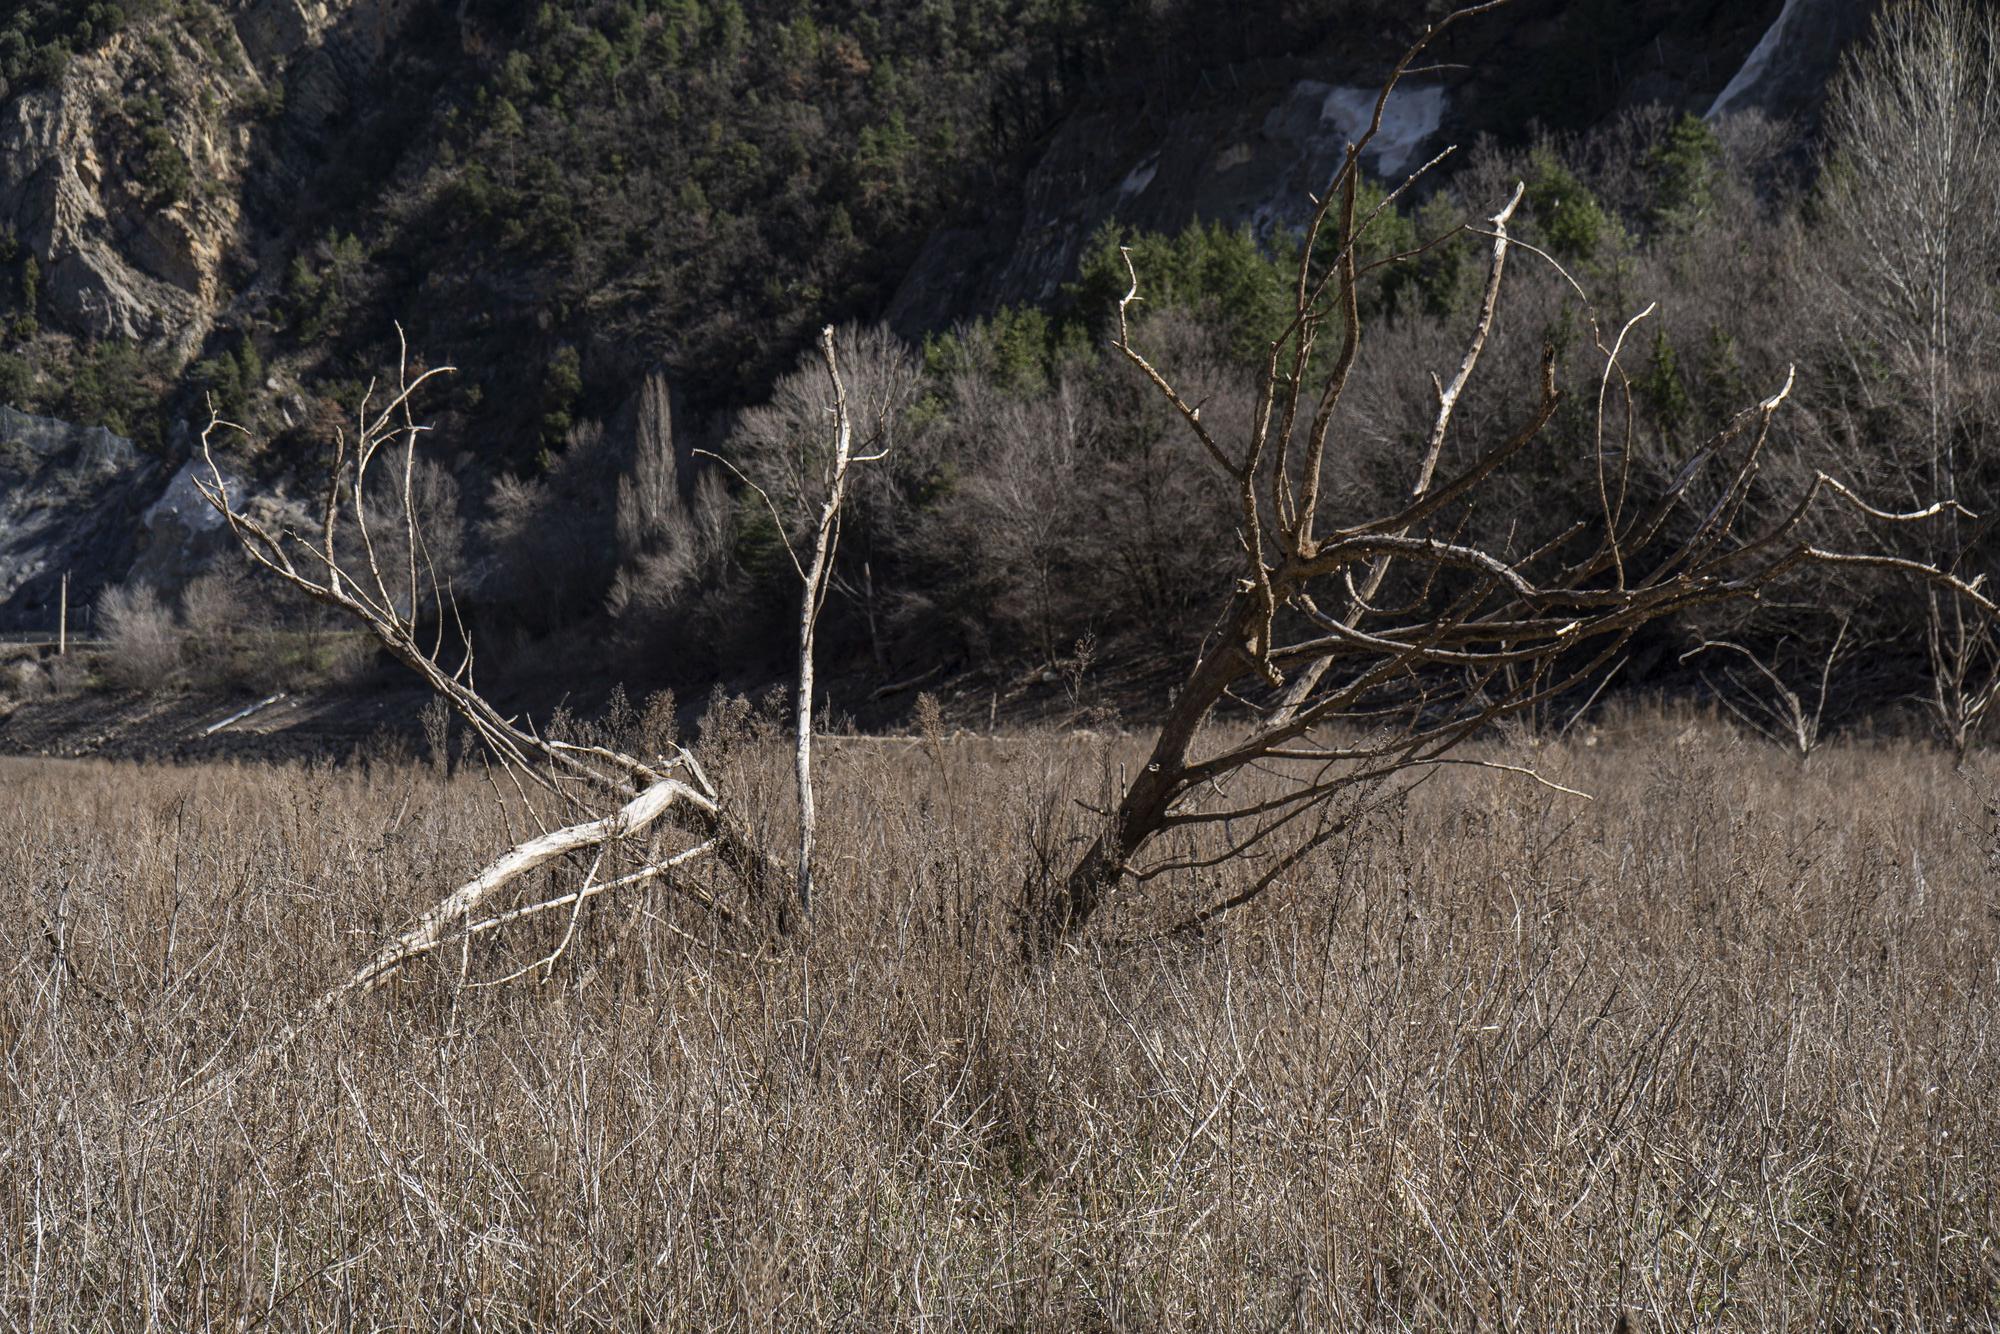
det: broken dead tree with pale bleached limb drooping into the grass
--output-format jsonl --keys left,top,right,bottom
{"left": 198, "top": 334, "right": 790, "bottom": 1060}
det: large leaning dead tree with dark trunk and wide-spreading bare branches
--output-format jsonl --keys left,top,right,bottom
{"left": 1030, "top": 4, "right": 1994, "bottom": 952}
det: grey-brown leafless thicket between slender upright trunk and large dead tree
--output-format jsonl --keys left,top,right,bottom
{"left": 896, "top": 308, "right": 1252, "bottom": 670}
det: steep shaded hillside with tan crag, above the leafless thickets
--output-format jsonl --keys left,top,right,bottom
{"left": 0, "top": 0, "right": 1870, "bottom": 466}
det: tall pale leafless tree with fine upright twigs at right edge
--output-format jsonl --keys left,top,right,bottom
{"left": 1814, "top": 0, "right": 2000, "bottom": 756}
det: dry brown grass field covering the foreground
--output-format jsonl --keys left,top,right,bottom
{"left": 0, "top": 720, "right": 2000, "bottom": 1330}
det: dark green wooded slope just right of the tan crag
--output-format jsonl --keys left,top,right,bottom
{"left": 0, "top": 0, "right": 1440, "bottom": 454}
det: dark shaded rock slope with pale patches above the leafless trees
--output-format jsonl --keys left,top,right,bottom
{"left": 890, "top": 0, "right": 1876, "bottom": 334}
